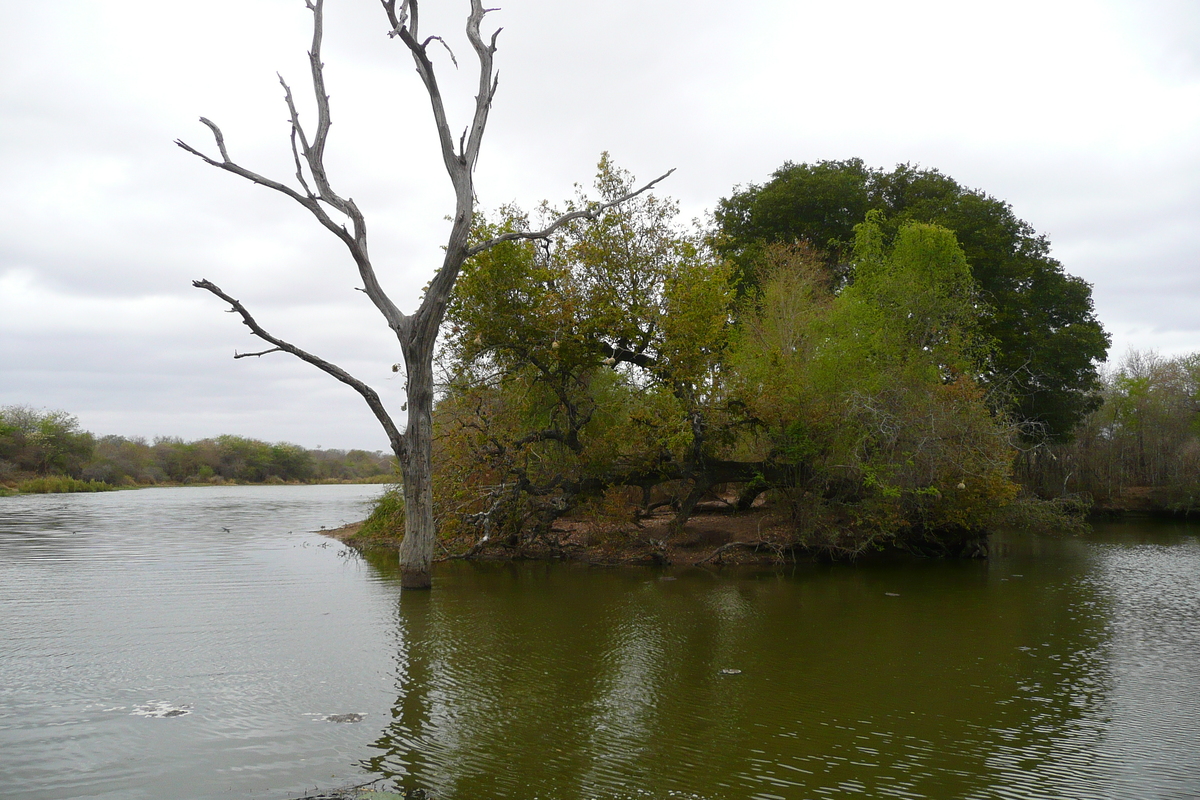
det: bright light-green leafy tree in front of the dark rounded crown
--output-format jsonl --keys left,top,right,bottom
{"left": 730, "top": 213, "right": 1015, "bottom": 554}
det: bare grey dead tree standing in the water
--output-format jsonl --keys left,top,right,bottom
{"left": 175, "top": 0, "right": 674, "bottom": 589}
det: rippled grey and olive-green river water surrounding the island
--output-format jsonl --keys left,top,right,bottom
{"left": 0, "top": 486, "right": 1200, "bottom": 800}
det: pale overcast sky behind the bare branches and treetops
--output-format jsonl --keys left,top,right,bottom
{"left": 0, "top": 0, "right": 1200, "bottom": 450}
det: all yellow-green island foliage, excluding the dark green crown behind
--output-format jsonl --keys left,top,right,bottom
{"left": 422, "top": 160, "right": 1015, "bottom": 554}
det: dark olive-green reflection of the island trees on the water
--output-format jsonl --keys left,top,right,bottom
{"left": 352, "top": 540, "right": 1132, "bottom": 800}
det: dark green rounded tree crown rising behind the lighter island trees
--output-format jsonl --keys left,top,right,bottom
{"left": 714, "top": 158, "right": 1109, "bottom": 440}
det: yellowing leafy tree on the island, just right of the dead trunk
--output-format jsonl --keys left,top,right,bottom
{"left": 438, "top": 156, "right": 732, "bottom": 544}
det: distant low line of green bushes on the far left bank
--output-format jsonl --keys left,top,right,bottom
{"left": 0, "top": 405, "right": 395, "bottom": 494}
